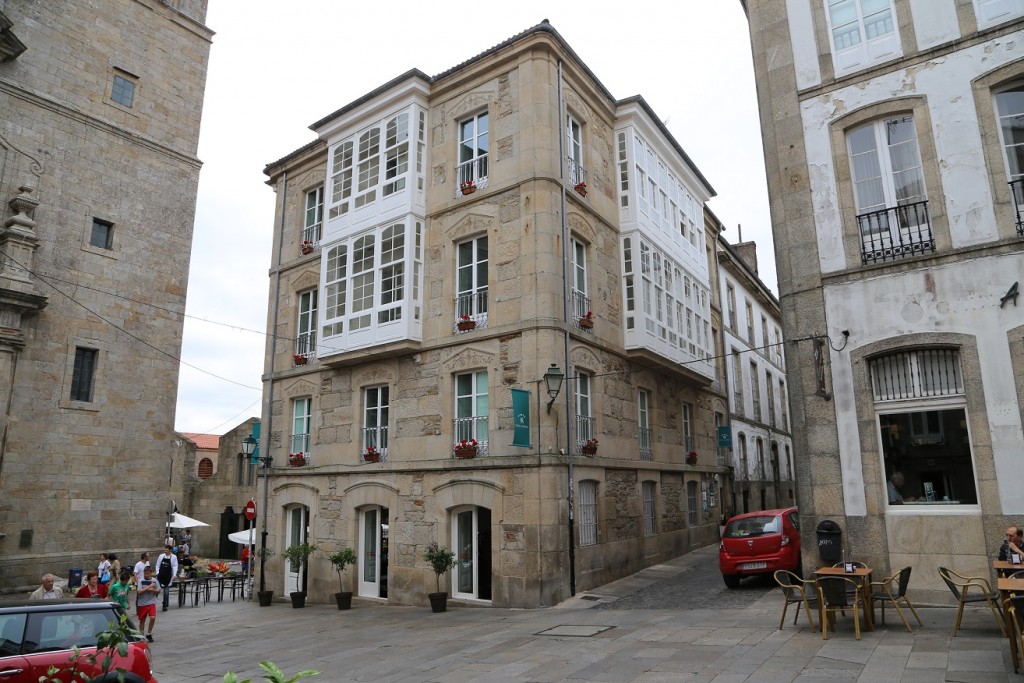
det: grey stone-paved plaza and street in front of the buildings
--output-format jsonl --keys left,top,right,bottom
{"left": 152, "top": 549, "right": 1024, "bottom": 683}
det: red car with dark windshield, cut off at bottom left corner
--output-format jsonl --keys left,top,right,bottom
{"left": 0, "top": 599, "right": 157, "bottom": 683}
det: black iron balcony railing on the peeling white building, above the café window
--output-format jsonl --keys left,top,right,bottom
{"left": 857, "top": 200, "right": 935, "bottom": 265}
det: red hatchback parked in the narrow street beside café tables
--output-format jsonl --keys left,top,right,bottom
{"left": 718, "top": 508, "right": 801, "bottom": 588}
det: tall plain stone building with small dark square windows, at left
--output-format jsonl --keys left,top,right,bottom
{"left": 0, "top": 0, "right": 212, "bottom": 590}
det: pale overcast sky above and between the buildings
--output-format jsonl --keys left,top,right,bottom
{"left": 175, "top": 0, "right": 776, "bottom": 434}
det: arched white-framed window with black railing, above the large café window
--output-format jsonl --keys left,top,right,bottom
{"left": 847, "top": 116, "right": 935, "bottom": 263}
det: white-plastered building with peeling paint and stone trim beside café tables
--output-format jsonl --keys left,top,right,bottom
{"left": 744, "top": 0, "right": 1024, "bottom": 591}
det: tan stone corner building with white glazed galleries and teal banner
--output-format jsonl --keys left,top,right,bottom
{"left": 260, "top": 24, "right": 727, "bottom": 606}
